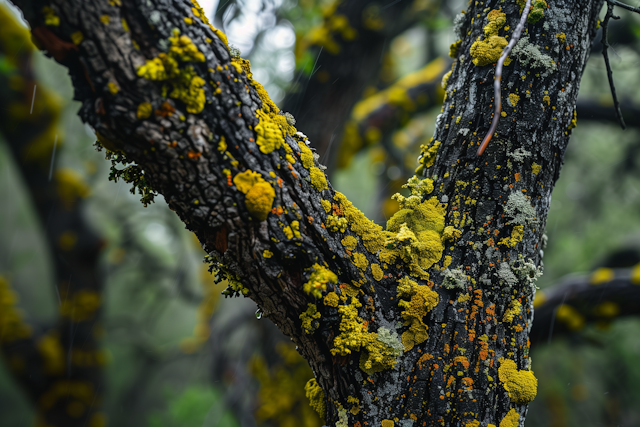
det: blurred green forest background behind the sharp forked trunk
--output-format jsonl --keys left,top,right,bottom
{"left": 0, "top": 0, "right": 640, "bottom": 427}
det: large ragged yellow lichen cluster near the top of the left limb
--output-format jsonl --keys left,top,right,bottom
{"left": 137, "top": 29, "right": 206, "bottom": 114}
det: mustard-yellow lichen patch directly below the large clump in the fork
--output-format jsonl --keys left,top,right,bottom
{"left": 397, "top": 276, "right": 439, "bottom": 351}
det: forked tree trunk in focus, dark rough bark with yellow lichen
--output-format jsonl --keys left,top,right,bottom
{"left": 8, "top": 0, "right": 602, "bottom": 427}
